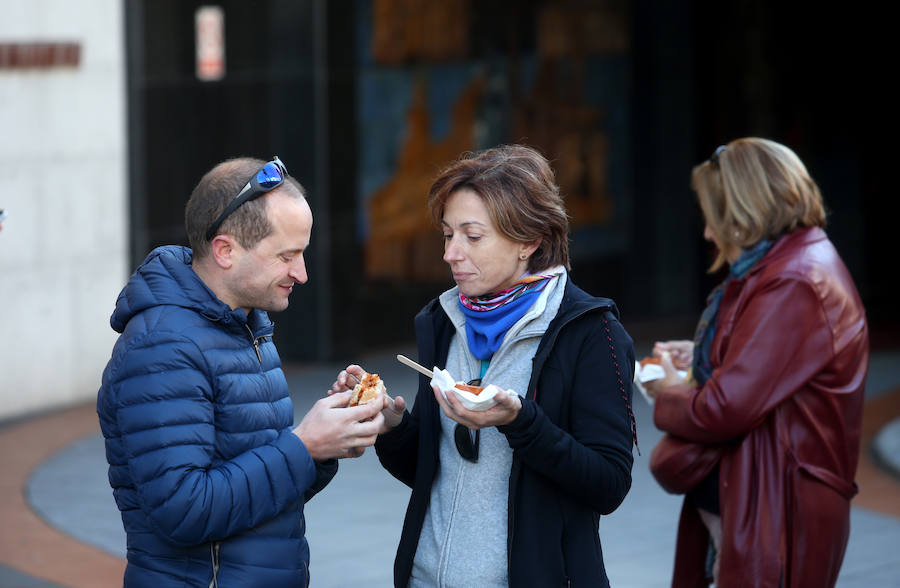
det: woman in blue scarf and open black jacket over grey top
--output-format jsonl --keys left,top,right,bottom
{"left": 332, "top": 145, "right": 636, "bottom": 588}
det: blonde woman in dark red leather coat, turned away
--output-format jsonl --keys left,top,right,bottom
{"left": 644, "top": 138, "right": 869, "bottom": 588}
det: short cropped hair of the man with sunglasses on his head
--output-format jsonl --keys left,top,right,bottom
{"left": 184, "top": 157, "right": 306, "bottom": 259}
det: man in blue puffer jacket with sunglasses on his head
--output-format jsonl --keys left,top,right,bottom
{"left": 97, "top": 157, "right": 383, "bottom": 588}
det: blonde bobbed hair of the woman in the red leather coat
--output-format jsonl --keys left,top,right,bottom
{"left": 691, "top": 137, "right": 825, "bottom": 272}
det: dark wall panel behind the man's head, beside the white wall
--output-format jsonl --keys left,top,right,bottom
{"left": 126, "top": 0, "right": 352, "bottom": 359}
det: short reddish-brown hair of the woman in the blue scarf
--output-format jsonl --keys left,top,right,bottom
{"left": 428, "top": 145, "right": 570, "bottom": 273}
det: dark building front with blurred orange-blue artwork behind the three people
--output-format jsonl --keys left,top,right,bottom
{"left": 126, "top": 0, "right": 897, "bottom": 360}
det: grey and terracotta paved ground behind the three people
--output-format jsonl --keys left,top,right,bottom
{"left": 0, "top": 346, "right": 900, "bottom": 588}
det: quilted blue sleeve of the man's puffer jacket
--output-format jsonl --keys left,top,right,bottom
{"left": 109, "top": 332, "right": 316, "bottom": 545}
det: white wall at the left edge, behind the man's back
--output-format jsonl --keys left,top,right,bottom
{"left": 0, "top": 0, "right": 128, "bottom": 420}
